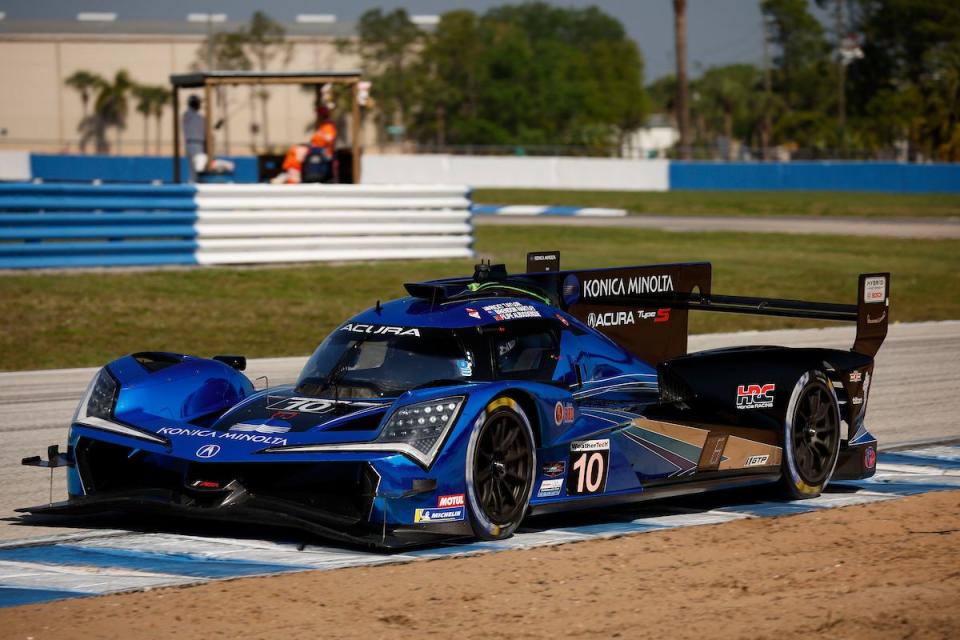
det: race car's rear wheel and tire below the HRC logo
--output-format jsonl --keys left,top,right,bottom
{"left": 780, "top": 370, "right": 840, "bottom": 500}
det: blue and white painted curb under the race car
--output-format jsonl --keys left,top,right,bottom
{"left": 0, "top": 445, "right": 960, "bottom": 607}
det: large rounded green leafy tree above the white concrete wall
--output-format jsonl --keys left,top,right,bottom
{"left": 398, "top": 3, "right": 647, "bottom": 154}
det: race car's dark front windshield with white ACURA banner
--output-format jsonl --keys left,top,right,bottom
{"left": 297, "top": 323, "right": 474, "bottom": 398}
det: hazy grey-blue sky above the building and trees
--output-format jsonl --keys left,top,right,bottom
{"left": 0, "top": 0, "right": 824, "bottom": 82}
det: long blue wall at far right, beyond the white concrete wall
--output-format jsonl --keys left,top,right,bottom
{"left": 670, "top": 161, "right": 960, "bottom": 193}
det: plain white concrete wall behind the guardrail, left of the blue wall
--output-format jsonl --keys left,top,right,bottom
{"left": 363, "top": 154, "right": 670, "bottom": 191}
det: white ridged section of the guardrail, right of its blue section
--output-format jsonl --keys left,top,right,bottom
{"left": 195, "top": 184, "right": 473, "bottom": 264}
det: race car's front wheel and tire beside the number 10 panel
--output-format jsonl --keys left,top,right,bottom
{"left": 466, "top": 397, "right": 537, "bottom": 540}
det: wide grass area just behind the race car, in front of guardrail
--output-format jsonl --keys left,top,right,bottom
{"left": 0, "top": 226, "right": 960, "bottom": 370}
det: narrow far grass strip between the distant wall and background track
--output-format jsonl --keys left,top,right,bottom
{"left": 473, "top": 189, "right": 960, "bottom": 218}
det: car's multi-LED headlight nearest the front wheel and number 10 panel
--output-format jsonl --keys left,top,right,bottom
{"left": 376, "top": 396, "right": 464, "bottom": 465}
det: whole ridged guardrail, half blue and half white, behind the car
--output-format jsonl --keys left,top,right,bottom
{"left": 0, "top": 184, "right": 473, "bottom": 269}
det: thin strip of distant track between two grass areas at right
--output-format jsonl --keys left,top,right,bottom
{"left": 473, "top": 215, "right": 960, "bottom": 240}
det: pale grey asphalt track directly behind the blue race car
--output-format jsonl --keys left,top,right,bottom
{"left": 0, "top": 321, "right": 960, "bottom": 540}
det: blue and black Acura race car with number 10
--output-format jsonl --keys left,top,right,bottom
{"left": 23, "top": 252, "right": 890, "bottom": 547}
